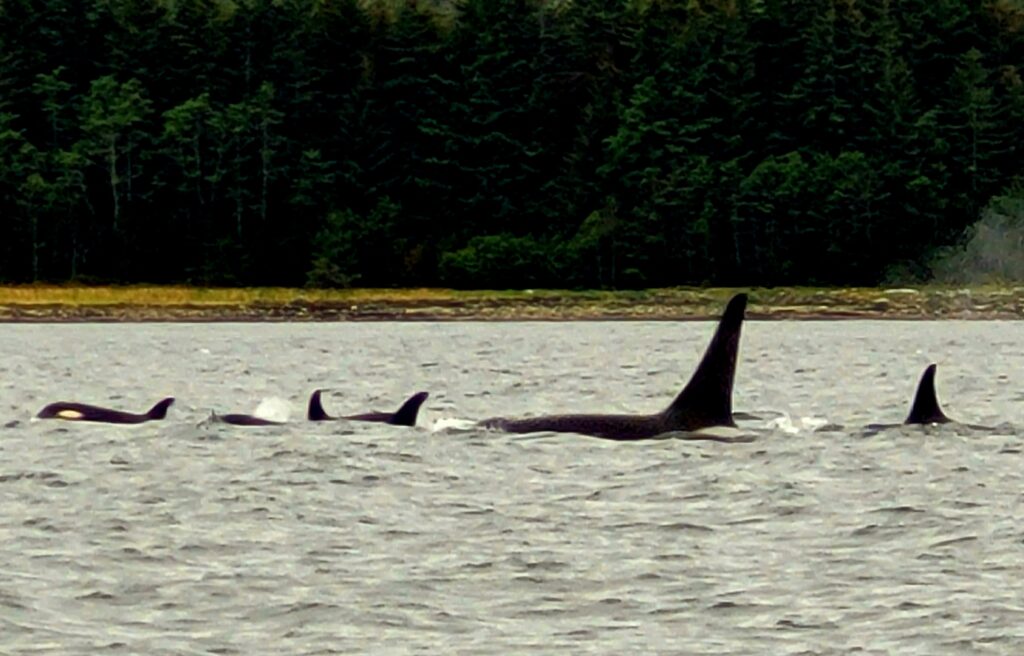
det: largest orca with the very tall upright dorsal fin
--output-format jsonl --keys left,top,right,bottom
{"left": 478, "top": 294, "right": 746, "bottom": 441}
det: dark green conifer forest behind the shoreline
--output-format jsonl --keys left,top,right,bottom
{"left": 0, "top": 0, "right": 1024, "bottom": 288}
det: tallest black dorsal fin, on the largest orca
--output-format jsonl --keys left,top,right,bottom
{"left": 663, "top": 294, "right": 746, "bottom": 431}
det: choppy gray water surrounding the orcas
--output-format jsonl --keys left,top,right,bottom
{"left": 0, "top": 321, "right": 1024, "bottom": 655}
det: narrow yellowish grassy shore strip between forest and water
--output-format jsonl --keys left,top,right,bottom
{"left": 0, "top": 286, "right": 1024, "bottom": 321}
